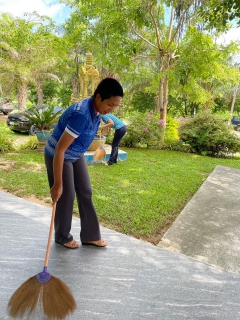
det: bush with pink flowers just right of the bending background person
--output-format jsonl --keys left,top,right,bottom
{"left": 115, "top": 111, "right": 164, "bottom": 148}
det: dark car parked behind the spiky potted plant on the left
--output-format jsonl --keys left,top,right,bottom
{"left": 7, "top": 105, "right": 64, "bottom": 136}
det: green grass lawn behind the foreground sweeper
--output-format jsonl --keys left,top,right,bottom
{"left": 0, "top": 119, "right": 240, "bottom": 244}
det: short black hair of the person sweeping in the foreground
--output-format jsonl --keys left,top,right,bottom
{"left": 93, "top": 78, "right": 123, "bottom": 101}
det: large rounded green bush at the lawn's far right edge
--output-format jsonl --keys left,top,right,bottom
{"left": 178, "top": 112, "right": 240, "bottom": 157}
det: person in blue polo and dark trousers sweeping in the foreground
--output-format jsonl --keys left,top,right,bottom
{"left": 45, "top": 78, "right": 123, "bottom": 249}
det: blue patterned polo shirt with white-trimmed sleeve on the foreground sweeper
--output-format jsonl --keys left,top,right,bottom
{"left": 45, "top": 97, "right": 102, "bottom": 161}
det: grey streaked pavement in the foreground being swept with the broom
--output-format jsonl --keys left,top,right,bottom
{"left": 0, "top": 168, "right": 240, "bottom": 320}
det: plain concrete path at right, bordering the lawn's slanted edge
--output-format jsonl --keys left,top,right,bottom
{"left": 159, "top": 166, "right": 240, "bottom": 276}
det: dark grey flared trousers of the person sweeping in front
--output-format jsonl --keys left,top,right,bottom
{"left": 45, "top": 154, "right": 101, "bottom": 244}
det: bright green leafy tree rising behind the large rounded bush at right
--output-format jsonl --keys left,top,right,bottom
{"left": 170, "top": 27, "right": 239, "bottom": 115}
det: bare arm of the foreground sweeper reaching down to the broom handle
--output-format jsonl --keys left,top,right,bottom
{"left": 50, "top": 131, "right": 75, "bottom": 201}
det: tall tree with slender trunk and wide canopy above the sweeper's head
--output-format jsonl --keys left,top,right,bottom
{"left": 60, "top": 0, "right": 218, "bottom": 126}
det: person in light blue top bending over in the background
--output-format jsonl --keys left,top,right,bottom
{"left": 100, "top": 114, "right": 127, "bottom": 166}
